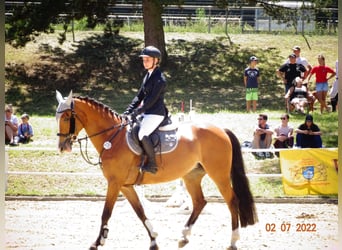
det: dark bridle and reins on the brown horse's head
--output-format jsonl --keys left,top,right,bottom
{"left": 56, "top": 100, "right": 128, "bottom": 168}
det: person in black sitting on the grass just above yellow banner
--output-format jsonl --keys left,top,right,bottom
{"left": 296, "top": 115, "right": 322, "bottom": 148}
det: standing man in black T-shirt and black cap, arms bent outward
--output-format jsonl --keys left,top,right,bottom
{"left": 277, "top": 54, "right": 306, "bottom": 110}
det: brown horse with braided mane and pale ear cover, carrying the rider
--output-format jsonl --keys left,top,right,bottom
{"left": 56, "top": 91, "right": 257, "bottom": 249}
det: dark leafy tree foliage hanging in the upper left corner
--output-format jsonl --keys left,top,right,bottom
{"left": 5, "top": 0, "right": 110, "bottom": 47}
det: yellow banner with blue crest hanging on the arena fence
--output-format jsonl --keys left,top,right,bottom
{"left": 280, "top": 148, "right": 338, "bottom": 195}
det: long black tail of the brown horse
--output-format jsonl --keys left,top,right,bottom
{"left": 225, "top": 129, "right": 258, "bottom": 227}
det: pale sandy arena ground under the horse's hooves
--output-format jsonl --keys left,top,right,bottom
{"left": 5, "top": 200, "right": 338, "bottom": 250}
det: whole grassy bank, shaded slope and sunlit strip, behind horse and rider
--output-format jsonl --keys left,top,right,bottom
{"left": 5, "top": 32, "right": 338, "bottom": 197}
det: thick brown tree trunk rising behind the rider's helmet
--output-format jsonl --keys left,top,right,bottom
{"left": 143, "top": 0, "right": 167, "bottom": 64}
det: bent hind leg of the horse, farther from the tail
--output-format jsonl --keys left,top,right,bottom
{"left": 178, "top": 165, "right": 207, "bottom": 248}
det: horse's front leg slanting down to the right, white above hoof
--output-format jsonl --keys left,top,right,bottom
{"left": 121, "top": 185, "right": 159, "bottom": 250}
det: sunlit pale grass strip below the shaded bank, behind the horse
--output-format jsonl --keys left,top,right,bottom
{"left": 6, "top": 112, "right": 336, "bottom": 197}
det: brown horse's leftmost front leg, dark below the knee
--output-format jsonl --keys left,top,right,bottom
{"left": 90, "top": 181, "right": 120, "bottom": 250}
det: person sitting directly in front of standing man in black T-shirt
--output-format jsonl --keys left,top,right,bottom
{"left": 285, "top": 77, "right": 308, "bottom": 114}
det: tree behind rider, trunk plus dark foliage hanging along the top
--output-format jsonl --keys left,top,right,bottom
{"left": 6, "top": 0, "right": 338, "bottom": 58}
